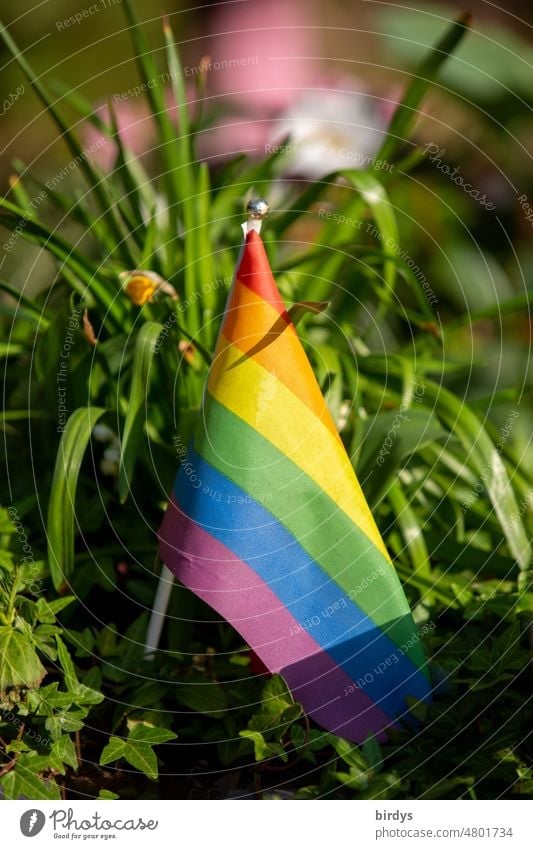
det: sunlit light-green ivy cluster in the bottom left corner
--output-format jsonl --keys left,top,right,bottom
{"left": 0, "top": 548, "right": 104, "bottom": 799}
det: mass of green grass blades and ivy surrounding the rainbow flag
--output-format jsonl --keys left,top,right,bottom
{"left": 0, "top": 6, "right": 533, "bottom": 799}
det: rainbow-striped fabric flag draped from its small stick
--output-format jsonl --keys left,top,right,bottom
{"left": 160, "top": 230, "right": 430, "bottom": 742}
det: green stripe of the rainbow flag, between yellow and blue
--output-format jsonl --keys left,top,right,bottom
{"left": 195, "top": 394, "right": 429, "bottom": 677}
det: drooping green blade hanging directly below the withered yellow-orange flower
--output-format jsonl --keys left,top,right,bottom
{"left": 118, "top": 321, "right": 163, "bottom": 504}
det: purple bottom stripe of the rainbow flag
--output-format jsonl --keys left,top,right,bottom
{"left": 159, "top": 498, "right": 393, "bottom": 742}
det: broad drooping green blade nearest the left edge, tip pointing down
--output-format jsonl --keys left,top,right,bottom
{"left": 46, "top": 407, "right": 105, "bottom": 592}
